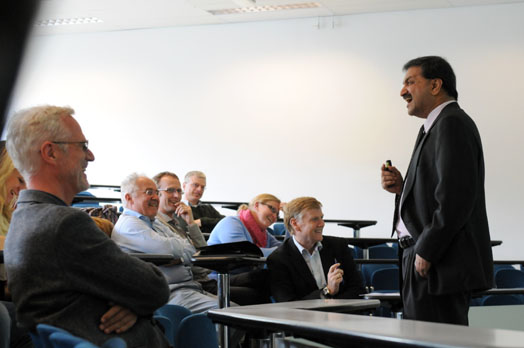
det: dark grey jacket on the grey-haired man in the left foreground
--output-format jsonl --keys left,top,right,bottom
{"left": 4, "top": 190, "right": 169, "bottom": 348}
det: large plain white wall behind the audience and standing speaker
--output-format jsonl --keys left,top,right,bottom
{"left": 7, "top": 4, "right": 524, "bottom": 259}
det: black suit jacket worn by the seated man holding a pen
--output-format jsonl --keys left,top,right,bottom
{"left": 267, "top": 236, "right": 366, "bottom": 302}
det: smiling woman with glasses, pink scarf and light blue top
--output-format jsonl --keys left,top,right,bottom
{"left": 207, "top": 193, "right": 282, "bottom": 256}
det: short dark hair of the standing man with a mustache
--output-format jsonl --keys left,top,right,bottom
{"left": 403, "top": 56, "right": 458, "bottom": 100}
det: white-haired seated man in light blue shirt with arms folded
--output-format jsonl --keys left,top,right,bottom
{"left": 111, "top": 173, "right": 218, "bottom": 313}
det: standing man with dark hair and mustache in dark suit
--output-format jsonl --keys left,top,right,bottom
{"left": 381, "top": 56, "right": 493, "bottom": 325}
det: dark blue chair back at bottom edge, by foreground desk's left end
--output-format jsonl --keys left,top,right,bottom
{"left": 175, "top": 313, "right": 218, "bottom": 348}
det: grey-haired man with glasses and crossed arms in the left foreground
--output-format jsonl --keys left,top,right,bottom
{"left": 4, "top": 106, "right": 169, "bottom": 347}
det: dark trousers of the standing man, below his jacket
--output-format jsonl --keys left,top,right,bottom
{"left": 402, "top": 247, "right": 471, "bottom": 325}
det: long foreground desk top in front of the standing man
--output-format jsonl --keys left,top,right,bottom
{"left": 208, "top": 300, "right": 524, "bottom": 348}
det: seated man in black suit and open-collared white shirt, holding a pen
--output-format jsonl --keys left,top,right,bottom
{"left": 267, "top": 197, "right": 366, "bottom": 302}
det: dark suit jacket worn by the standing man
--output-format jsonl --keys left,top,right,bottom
{"left": 393, "top": 103, "right": 493, "bottom": 295}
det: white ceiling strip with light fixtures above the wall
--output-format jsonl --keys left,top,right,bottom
{"left": 35, "top": 0, "right": 524, "bottom": 35}
